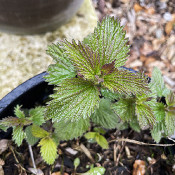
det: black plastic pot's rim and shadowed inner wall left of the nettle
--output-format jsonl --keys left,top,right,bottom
{"left": 0, "top": 72, "right": 53, "bottom": 139}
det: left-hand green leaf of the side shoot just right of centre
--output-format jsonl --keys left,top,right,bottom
{"left": 112, "top": 98, "right": 135, "bottom": 122}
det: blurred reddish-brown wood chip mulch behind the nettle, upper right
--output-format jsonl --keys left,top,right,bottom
{"left": 93, "top": 0, "right": 175, "bottom": 92}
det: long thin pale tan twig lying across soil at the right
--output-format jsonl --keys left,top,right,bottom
{"left": 109, "top": 138, "right": 175, "bottom": 147}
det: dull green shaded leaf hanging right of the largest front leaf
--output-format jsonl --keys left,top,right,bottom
{"left": 91, "top": 99, "right": 120, "bottom": 129}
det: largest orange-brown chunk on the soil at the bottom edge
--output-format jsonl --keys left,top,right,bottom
{"left": 132, "top": 160, "right": 146, "bottom": 175}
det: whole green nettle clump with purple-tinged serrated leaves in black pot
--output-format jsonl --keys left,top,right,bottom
{"left": 0, "top": 17, "right": 175, "bottom": 164}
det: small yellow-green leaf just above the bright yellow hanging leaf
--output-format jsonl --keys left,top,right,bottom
{"left": 32, "top": 125, "right": 50, "bottom": 138}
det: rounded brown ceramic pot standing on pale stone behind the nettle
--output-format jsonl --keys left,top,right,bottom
{"left": 0, "top": 0, "right": 83, "bottom": 34}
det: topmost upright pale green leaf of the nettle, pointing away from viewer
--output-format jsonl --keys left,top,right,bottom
{"left": 84, "top": 17, "right": 129, "bottom": 67}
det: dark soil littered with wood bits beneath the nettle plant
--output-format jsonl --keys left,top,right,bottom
{"left": 1, "top": 129, "right": 175, "bottom": 175}
